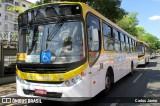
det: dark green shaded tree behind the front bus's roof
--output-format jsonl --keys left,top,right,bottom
{"left": 36, "top": 0, "right": 127, "bottom": 22}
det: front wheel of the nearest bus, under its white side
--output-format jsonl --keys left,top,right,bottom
{"left": 104, "top": 72, "right": 112, "bottom": 94}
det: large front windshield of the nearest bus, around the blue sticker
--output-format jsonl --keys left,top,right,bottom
{"left": 18, "top": 20, "right": 85, "bottom": 63}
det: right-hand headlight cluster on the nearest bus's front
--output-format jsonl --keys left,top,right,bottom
{"left": 64, "top": 75, "right": 82, "bottom": 87}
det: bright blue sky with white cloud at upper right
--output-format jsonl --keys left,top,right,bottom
{"left": 28, "top": 0, "right": 160, "bottom": 39}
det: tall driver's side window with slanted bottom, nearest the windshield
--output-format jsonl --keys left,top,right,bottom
{"left": 87, "top": 14, "right": 100, "bottom": 67}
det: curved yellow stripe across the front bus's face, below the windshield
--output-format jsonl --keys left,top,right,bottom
{"left": 16, "top": 62, "right": 88, "bottom": 81}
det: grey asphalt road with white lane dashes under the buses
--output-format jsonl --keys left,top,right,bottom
{"left": 0, "top": 57, "right": 160, "bottom": 106}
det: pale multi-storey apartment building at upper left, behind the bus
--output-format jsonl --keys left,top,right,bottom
{"left": 0, "top": 0, "right": 32, "bottom": 40}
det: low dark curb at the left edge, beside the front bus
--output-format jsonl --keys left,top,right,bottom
{"left": 0, "top": 76, "right": 16, "bottom": 85}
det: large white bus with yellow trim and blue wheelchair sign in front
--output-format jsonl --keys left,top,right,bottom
{"left": 16, "top": 2, "right": 138, "bottom": 101}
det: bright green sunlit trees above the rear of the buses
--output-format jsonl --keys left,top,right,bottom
{"left": 117, "top": 12, "right": 160, "bottom": 49}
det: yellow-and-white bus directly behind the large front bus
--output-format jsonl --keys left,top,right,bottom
{"left": 137, "top": 41, "right": 150, "bottom": 65}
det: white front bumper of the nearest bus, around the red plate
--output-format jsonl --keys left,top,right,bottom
{"left": 16, "top": 78, "right": 91, "bottom": 102}
